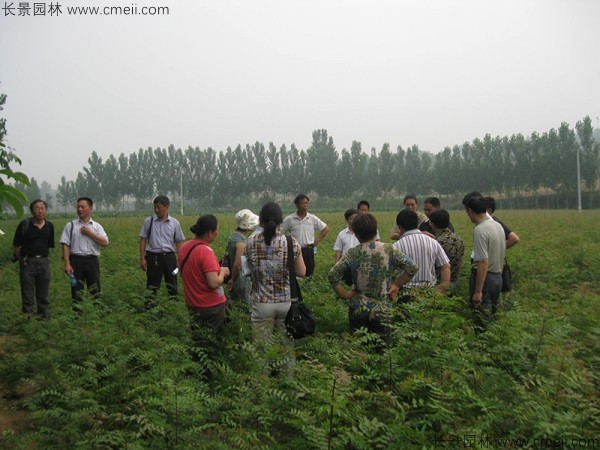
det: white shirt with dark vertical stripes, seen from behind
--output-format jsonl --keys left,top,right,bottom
{"left": 394, "top": 230, "right": 450, "bottom": 288}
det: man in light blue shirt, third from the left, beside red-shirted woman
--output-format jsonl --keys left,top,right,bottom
{"left": 139, "top": 195, "right": 185, "bottom": 306}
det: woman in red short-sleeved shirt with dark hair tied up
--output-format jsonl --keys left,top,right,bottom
{"left": 179, "top": 214, "right": 229, "bottom": 338}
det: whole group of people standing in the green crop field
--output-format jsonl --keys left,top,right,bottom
{"left": 13, "top": 192, "right": 519, "bottom": 360}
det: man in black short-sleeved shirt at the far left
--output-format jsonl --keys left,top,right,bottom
{"left": 13, "top": 199, "right": 54, "bottom": 319}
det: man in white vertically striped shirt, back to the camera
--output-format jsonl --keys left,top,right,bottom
{"left": 394, "top": 209, "right": 450, "bottom": 301}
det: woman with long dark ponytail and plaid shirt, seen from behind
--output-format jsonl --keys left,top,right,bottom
{"left": 246, "top": 202, "right": 306, "bottom": 376}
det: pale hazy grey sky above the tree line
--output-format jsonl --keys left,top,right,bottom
{"left": 0, "top": 0, "right": 600, "bottom": 188}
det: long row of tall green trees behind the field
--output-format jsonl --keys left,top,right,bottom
{"left": 18, "top": 116, "right": 600, "bottom": 210}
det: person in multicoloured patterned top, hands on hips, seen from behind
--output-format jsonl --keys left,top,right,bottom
{"left": 329, "top": 213, "right": 418, "bottom": 339}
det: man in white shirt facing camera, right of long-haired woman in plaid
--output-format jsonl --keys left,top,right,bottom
{"left": 280, "top": 194, "right": 329, "bottom": 277}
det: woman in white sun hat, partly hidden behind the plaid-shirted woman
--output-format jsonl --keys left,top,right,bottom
{"left": 227, "top": 209, "right": 258, "bottom": 304}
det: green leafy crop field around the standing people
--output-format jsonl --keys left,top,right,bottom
{"left": 0, "top": 210, "right": 600, "bottom": 450}
